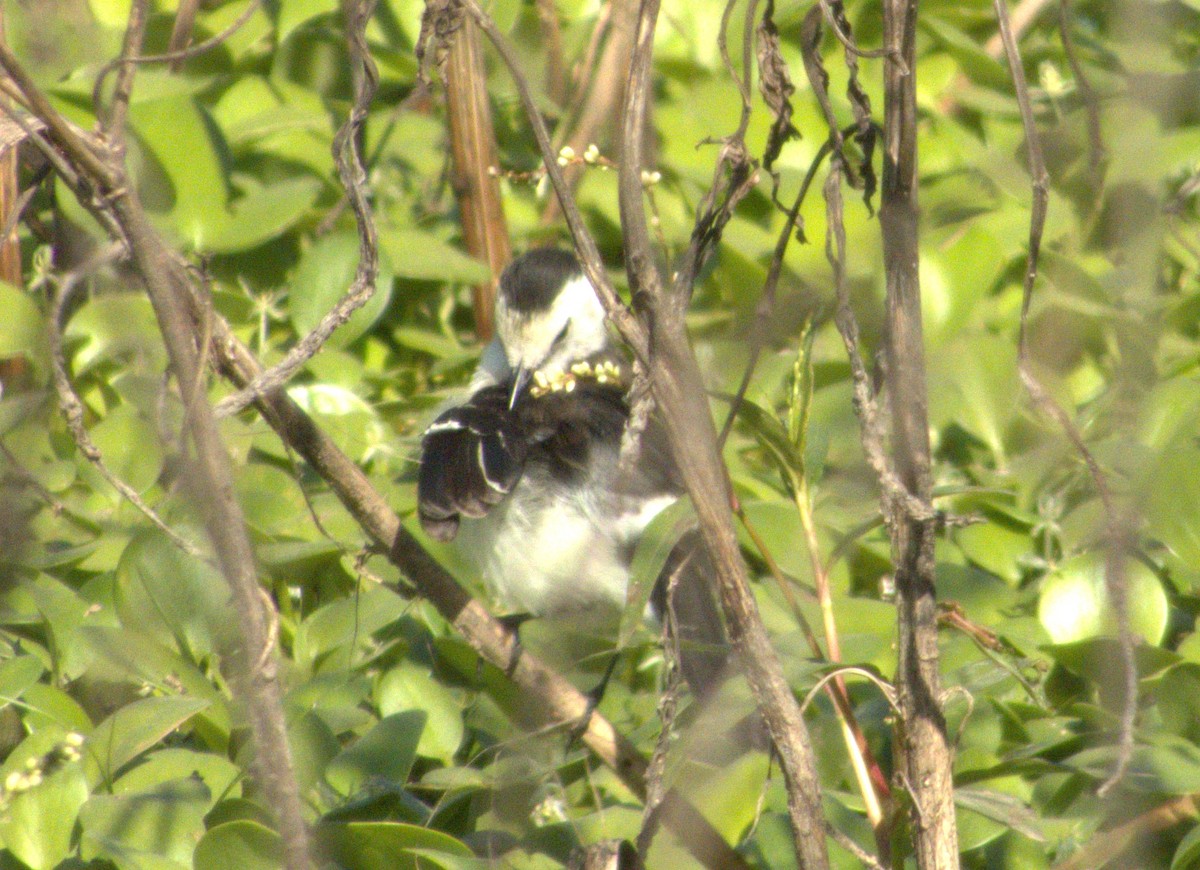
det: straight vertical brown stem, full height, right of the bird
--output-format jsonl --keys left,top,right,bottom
{"left": 880, "top": 0, "right": 959, "bottom": 870}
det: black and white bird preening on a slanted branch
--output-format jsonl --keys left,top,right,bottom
{"left": 418, "top": 248, "right": 727, "bottom": 696}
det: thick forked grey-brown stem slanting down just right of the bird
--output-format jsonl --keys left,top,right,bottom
{"left": 619, "top": 0, "right": 829, "bottom": 870}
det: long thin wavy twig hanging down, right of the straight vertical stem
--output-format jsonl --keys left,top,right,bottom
{"left": 994, "top": 0, "right": 1138, "bottom": 797}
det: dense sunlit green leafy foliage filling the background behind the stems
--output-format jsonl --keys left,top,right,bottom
{"left": 0, "top": 0, "right": 1200, "bottom": 868}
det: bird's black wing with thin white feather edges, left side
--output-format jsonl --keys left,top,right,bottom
{"left": 416, "top": 386, "right": 528, "bottom": 541}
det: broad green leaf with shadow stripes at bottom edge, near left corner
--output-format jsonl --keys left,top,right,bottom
{"left": 79, "top": 778, "right": 211, "bottom": 868}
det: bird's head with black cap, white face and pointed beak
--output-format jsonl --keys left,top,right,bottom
{"left": 496, "top": 247, "right": 610, "bottom": 407}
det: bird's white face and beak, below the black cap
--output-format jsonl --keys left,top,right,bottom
{"left": 496, "top": 275, "right": 610, "bottom": 401}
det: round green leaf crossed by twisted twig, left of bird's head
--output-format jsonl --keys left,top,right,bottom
{"left": 288, "top": 232, "right": 392, "bottom": 348}
